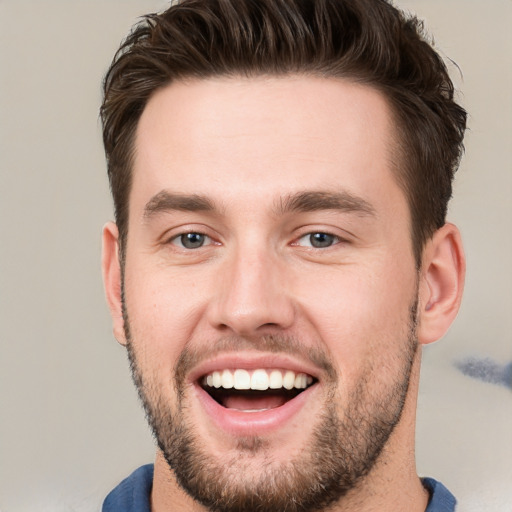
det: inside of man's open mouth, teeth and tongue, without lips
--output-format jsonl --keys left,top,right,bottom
{"left": 199, "top": 369, "right": 316, "bottom": 412}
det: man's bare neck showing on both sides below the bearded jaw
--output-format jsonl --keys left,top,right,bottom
{"left": 151, "top": 349, "right": 429, "bottom": 512}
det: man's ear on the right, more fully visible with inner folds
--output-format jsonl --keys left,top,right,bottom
{"left": 418, "top": 223, "right": 466, "bottom": 344}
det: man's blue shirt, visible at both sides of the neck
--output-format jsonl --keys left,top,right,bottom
{"left": 101, "top": 464, "right": 456, "bottom": 512}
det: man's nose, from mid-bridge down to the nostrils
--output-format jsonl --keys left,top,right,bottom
{"left": 209, "top": 244, "right": 295, "bottom": 337}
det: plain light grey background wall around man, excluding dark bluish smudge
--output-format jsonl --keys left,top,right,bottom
{"left": 0, "top": 0, "right": 512, "bottom": 512}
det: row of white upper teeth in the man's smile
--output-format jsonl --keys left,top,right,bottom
{"left": 203, "top": 369, "right": 313, "bottom": 391}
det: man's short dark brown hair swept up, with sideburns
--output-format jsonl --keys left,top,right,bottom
{"left": 101, "top": 0, "right": 466, "bottom": 265}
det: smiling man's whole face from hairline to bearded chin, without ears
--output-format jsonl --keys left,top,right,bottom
{"left": 120, "top": 77, "right": 417, "bottom": 510}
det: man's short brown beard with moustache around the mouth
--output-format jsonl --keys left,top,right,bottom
{"left": 123, "top": 302, "right": 418, "bottom": 512}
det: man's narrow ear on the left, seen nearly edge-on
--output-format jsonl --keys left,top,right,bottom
{"left": 101, "top": 222, "right": 126, "bottom": 345}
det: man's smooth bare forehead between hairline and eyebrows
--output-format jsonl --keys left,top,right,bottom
{"left": 131, "top": 76, "right": 404, "bottom": 214}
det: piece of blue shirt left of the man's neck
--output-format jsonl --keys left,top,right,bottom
{"left": 101, "top": 464, "right": 153, "bottom": 512}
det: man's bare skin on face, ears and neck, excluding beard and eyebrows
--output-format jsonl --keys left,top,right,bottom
{"left": 103, "top": 76, "right": 465, "bottom": 512}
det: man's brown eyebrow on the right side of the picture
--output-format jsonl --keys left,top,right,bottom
{"left": 276, "top": 190, "right": 375, "bottom": 216}
